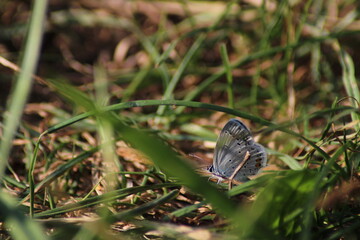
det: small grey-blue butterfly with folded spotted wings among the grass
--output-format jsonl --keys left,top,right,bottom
{"left": 208, "top": 119, "right": 267, "bottom": 184}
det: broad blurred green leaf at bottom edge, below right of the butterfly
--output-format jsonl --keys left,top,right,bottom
{"left": 234, "top": 169, "right": 317, "bottom": 239}
